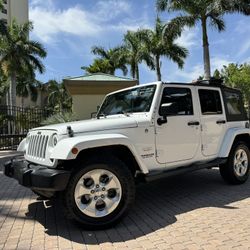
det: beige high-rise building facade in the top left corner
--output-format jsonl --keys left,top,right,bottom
{"left": 0, "top": 0, "right": 29, "bottom": 24}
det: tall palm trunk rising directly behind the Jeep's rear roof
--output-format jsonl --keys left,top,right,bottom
{"left": 201, "top": 17, "right": 211, "bottom": 80}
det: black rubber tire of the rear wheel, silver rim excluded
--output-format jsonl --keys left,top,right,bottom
{"left": 220, "top": 141, "right": 250, "bottom": 185}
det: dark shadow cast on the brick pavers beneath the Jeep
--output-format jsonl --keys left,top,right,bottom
{"left": 20, "top": 169, "right": 250, "bottom": 245}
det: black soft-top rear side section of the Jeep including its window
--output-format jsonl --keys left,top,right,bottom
{"left": 223, "top": 90, "right": 247, "bottom": 121}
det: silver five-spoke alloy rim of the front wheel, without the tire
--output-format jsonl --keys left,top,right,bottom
{"left": 74, "top": 169, "right": 122, "bottom": 217}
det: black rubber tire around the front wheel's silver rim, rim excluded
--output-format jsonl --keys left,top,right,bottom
{"left": 63, "top": 156, "right": 135, "bottom": 230}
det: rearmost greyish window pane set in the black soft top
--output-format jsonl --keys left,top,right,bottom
{"left": 224, "top": 91, "right": 242, "bottom": 115}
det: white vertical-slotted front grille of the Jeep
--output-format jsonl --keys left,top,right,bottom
{"left": 27, "top": 135, "right": 49, "bottom": 159}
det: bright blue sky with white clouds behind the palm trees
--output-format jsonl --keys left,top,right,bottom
{"left": 29, "top": 0, "right": 250, "bottom": 83}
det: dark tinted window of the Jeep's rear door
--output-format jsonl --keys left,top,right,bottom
{"left": 199, "top": 89, "right": 222, "bottom": 115}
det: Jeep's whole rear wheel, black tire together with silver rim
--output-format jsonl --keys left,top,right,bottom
{"left": 220, "top": 142, "right": 250, "bottom": 184}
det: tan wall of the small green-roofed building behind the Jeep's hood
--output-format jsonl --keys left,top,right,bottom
{"left": 72, "top": 95, "right": 105, "bottom": 120}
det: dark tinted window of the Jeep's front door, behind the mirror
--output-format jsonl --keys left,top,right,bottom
{"left": 159, "top": 88, "right": 193, "bottom": 116}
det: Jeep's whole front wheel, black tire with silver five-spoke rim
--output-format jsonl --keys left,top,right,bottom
{"left": 64, "top": 157, "right": 135, "bottom": 229}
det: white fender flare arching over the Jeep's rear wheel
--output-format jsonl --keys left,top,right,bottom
{"left": 219, "top": 128, "right": 250, "bottom": 158}
